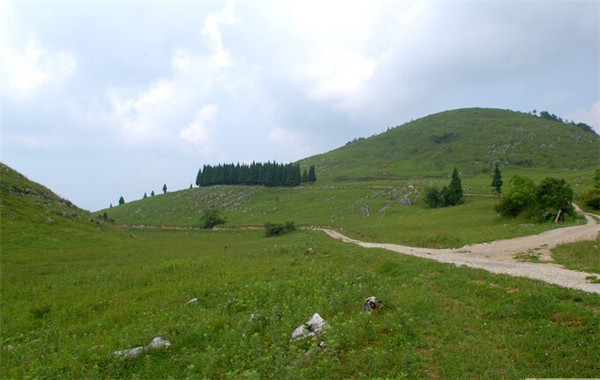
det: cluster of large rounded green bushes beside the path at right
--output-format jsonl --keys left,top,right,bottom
{"left": 494, "top": 176, "right": 575, "bottom": 222}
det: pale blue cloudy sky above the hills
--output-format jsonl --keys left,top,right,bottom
{"left": 0, "top": 0, "right": 600, "bottom": 211}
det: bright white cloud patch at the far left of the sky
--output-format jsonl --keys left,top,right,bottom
{"left": 3, "top": 38, "right": 77, "bottom": 96}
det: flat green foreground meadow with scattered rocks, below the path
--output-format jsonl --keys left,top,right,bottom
{"left": 1, "top": 229, "right": 600, "bottom": 378}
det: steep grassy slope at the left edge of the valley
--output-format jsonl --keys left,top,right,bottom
{"left": 0, "top": 163, "right": 112, "bottom": 246}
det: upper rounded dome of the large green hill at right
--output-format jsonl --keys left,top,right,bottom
{"left": 300, "top": 108, "right": 600, "bottom": 182}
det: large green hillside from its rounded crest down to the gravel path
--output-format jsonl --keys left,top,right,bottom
{"left": 95, "top": 109, "right": 600, "bottom": 247}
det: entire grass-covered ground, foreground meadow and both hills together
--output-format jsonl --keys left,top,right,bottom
{"left": 0, "top": 105, "right": 600, "bottom": 379}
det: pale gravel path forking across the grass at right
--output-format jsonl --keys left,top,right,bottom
{"left": 315, "top": 214, "right": 600, "bottom": 294}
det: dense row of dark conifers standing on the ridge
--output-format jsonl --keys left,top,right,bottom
{"left": 196, "top": 162, "right": 317, "bottom": 187}
